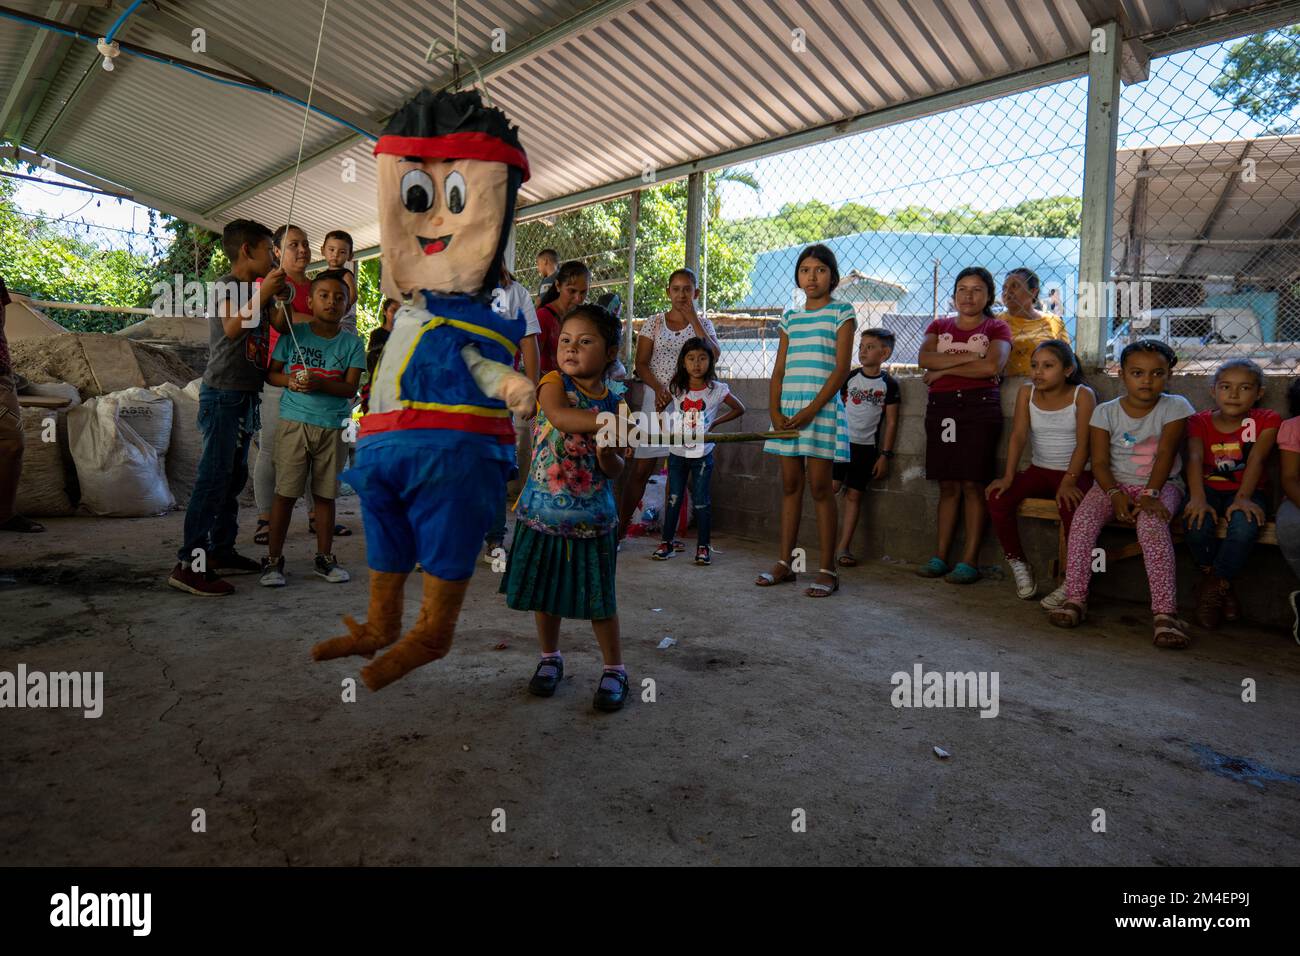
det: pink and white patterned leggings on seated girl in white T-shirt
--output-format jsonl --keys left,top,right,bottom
{"left": 1065, "top": 484, "right": 1183, "bottom": 614}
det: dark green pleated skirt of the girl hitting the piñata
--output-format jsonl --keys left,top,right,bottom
{"left": 499, "top": 522, "right": 618, "bottom": 620}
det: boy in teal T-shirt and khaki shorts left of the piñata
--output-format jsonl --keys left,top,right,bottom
{"left": 261, "top": 269, "right": 365, "bottom": 588}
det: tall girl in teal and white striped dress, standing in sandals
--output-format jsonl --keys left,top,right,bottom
{"left": 754, "top": 245, "right": 857, "bottom": 597}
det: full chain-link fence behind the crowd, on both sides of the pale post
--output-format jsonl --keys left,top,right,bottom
{"left": 517, "top": 14, "right": 1300, "bottom": 378}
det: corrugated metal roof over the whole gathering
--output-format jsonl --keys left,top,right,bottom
{"left": 0, "top": 0, "right": 1289, "bottom": 238}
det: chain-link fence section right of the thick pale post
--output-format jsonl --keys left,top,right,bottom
{"left": 1106, "top": 15, "right": 1300, "bottom": 373}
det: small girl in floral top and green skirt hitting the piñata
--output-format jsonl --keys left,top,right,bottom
{"left": 501, "top": 304, "right": 628, "bottom": 710}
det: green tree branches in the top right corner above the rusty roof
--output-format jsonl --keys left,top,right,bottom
{"left": 1210, "top": 23, "right": 1300, "bottom": 133}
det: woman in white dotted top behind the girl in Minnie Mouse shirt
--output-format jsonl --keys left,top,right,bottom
{"left": 619, "top": 269, "right": 722, "bottom": 546}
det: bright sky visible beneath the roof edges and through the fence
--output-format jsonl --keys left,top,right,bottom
{"left": 5, "top": 44, "right": 1262, "bottom": 252}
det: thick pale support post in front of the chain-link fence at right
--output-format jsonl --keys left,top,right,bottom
{"left": 1075, "top": 21, "right": 1121, "bottom": 368}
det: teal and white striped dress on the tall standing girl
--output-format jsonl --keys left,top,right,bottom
{"left": 763, "top": 299, "right": 854, "bottom": 462}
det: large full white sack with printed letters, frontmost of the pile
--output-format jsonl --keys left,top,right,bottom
{"left": 68, "top": 395, "right": 176, "bottom": 518}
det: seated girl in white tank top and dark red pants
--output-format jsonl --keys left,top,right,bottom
{"left": 985, "top": 339, "right": 1097, "bottom": 600}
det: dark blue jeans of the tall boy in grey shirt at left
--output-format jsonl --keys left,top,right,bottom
{"left": 177, "top": 382, "right": 261, "bottom": 564}
